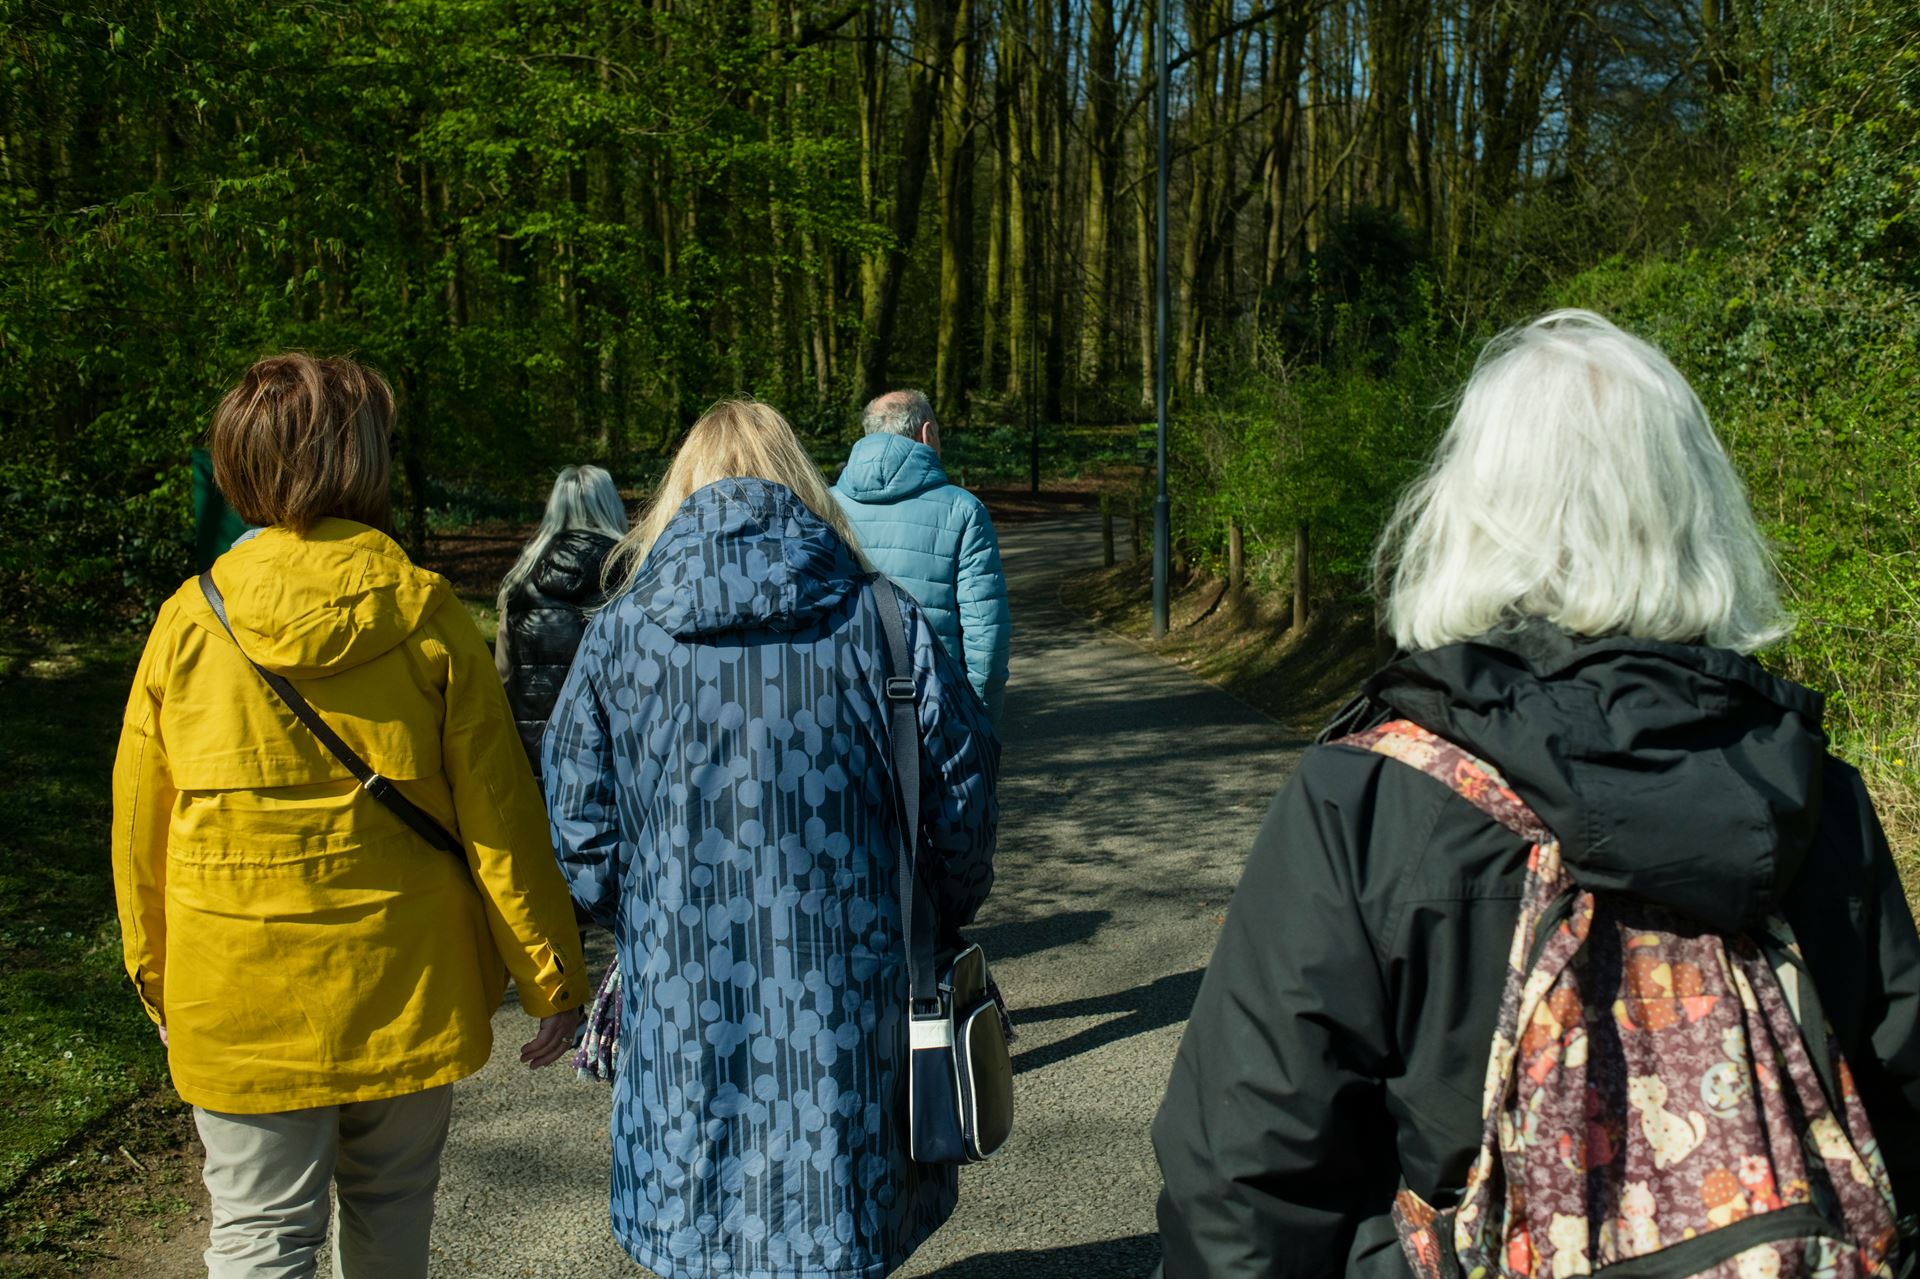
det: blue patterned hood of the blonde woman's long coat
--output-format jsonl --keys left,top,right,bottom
{"left": 634, "top": 480, "right": 868, "bottom": 640}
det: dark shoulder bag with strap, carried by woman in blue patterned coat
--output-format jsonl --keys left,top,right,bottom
{"left": 874, "top": 574, "right": 1014, "bottom": 1164}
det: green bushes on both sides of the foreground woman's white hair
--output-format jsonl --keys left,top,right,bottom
{"left": 1175, "top": 2, "right": 1920, "bottom": 787}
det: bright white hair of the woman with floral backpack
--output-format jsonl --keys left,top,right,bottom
{"left": 1375, "top": 311, "right": 1793, "bottom": 653}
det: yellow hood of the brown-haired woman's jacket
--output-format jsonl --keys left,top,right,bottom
{"left": 192, "top": 519, "right": 453, "bottom": 678}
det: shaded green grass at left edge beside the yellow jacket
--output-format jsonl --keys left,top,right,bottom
{"left": 0, "top": 640, "right": 180, "bottom": 1273}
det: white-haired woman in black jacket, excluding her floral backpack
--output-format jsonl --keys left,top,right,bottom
{"left": 1154, "top": 311, "right": 1920, "bottom": 1279}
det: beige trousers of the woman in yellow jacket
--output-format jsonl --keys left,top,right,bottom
{"left": 194, "top": 1085, "right": 453, "bottom": 1279}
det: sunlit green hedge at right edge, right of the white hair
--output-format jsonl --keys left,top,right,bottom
{"left": 1557, "top": 4, "right": 1920, "bottom": 756}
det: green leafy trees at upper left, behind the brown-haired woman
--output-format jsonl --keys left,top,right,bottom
{"left": 0, "top": 0, "right": 881, "bottom": 626}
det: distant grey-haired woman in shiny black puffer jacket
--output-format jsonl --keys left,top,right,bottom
{"left": 493, "top": 467, "right": 626, "bottom": 776}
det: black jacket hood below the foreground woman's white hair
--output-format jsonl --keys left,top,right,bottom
{"left": 1367, "top": 622, "right": 1826, "bottom": 931}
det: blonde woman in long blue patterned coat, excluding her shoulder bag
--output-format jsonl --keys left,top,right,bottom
{"left": 543, "top": 401, "right": 1000, "bottom": 1279}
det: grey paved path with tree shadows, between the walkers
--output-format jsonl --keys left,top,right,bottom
{"left": 345, "top": 519, "right": 1298, "bottom": 1279}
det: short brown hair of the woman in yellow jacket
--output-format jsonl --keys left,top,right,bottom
{"left": 207, "top": 351, "right": 394, "bottom": 534}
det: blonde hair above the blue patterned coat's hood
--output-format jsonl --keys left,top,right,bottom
{"left": 605, "top": 399, "right": 870, "bottom": 595}
